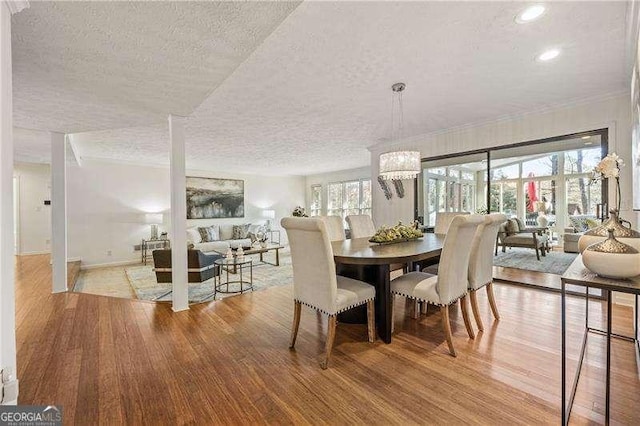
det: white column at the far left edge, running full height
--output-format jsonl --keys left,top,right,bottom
{"left": 0, "top": 1, "right": 28, "bottom": 404}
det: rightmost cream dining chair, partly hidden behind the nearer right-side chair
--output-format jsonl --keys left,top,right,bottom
{"left": 469, "top": 213, "right": 507, "bottom": 331}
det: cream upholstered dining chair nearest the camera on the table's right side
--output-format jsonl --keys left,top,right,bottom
{"left": 391, "top": 215, "right": 483, "bottom": 356}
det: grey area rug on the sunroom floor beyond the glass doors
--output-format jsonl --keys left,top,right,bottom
{"left": 493, "top": 247, "right": 578, "bottom": 275}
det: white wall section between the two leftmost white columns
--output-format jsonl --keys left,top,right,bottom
{"left": 13, "top": 163, "right": 51, "bottom": 254}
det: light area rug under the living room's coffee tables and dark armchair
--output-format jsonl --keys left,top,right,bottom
{"left": 125, "top": 249, "right": 293, "bottom": 303}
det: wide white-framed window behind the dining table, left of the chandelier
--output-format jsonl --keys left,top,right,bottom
{"left": 327, "top": 179, "right": 371, "bottom": 223}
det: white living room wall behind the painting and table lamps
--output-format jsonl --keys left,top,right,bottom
{"left": 67, "top": 161, "right": 305, "bottom": 267}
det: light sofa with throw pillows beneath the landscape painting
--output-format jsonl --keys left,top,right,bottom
{"left": 187, "top": 222, "right": 267, "bottom": 253}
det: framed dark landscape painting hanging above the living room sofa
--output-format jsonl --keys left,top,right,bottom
{"left": 187, "top": 177, "right": 244, "bottom": 219}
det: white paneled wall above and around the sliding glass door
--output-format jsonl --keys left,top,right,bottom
{"left": 371, "top": 94, "right": 638, "bottom": 231}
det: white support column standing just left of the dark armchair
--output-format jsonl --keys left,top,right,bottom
{"left": 169, "top": 115, "right": 189, "bottom": 312}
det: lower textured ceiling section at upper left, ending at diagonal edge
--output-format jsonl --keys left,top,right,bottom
{"left": 12, "top": 1, "right": 297, "bottom": 133}
